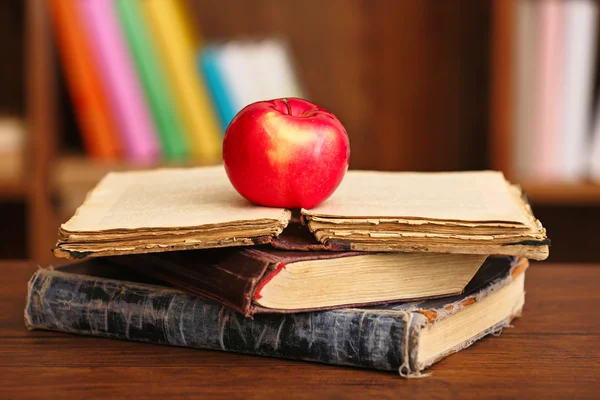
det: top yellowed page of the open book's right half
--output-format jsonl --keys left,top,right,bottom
{"left": 302, "top": 171, "right": 531, "bottom": 225}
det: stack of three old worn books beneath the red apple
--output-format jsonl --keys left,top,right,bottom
{"left": 25, "top": 166, "right": 549, "bottom": 377}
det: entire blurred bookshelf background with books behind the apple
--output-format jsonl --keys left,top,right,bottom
{"left": 0, "top": 0, "right": 600, "bottom": 262}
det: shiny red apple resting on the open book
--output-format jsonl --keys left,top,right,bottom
{"left": 223, "top": 98, "right": 350, "bottom": 208}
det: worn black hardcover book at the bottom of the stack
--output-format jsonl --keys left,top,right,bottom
{"left": 25, "top": 257, "right": 527, "bottom": 377}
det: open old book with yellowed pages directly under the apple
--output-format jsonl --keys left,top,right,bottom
{"left": 54, "top": 166, "right": 548, "bottom": 260}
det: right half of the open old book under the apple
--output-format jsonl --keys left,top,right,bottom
{"left": 302, "top": 171, "right": 549, "bottom": 260}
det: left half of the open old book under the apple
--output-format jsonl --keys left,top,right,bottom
{"left": 54, "top": 166, "right": 291, "bottom": 258}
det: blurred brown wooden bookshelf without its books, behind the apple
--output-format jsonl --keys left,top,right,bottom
{"left": 0, "top": 0, "right": 600, "bottom": 262}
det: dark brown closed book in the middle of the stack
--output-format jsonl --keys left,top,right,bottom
{"left": 110, "top": 246, "right": 488, "bottom": 316}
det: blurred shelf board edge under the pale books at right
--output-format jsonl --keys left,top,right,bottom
{"left": 521, "top": 182, "right": 600, "bottom": 206}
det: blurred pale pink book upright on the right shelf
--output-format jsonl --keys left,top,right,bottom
{"left": 531, "top": 0, "right": 564, "bottom": 182}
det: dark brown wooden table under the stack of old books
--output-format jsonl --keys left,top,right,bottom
{"left": 0, "top": 263, "right": 600, "bottom": 399}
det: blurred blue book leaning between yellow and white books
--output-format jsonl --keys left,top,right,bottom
{"left": 198, "top": 45, "right": 239, "bottom": 132}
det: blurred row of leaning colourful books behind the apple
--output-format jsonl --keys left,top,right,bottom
{"left": 46, "top": 0, "right": 304, "bottom": 167}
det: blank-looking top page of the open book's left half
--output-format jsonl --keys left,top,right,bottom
{"left": 62, "top": 166, "right": 289, "bottom": 232}
